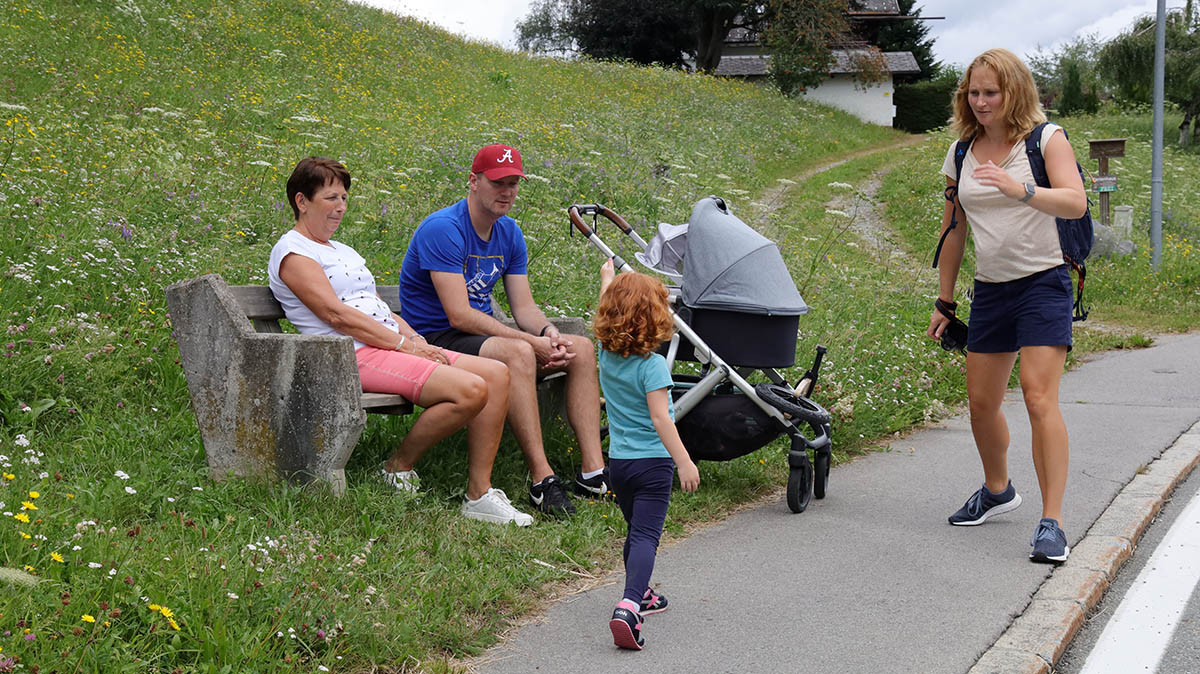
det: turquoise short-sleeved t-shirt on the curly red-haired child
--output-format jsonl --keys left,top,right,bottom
{"left": 600, "top": 349, "right": 674, "bottom": 458}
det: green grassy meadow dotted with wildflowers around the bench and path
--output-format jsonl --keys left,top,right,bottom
{"left": 0, "top": 0, "right": 1200, "bottom": 673}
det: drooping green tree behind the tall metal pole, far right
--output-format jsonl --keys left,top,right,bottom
{"left": 1099, "top": 0, "right": 1200, "bottom": 145}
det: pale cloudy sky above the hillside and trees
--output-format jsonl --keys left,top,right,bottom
{"left": 360, "top": 0, "right": 1161, "bottom": 65}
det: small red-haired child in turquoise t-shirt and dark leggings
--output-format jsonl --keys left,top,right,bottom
{"left": 593, "top": 259, "right": 700, "bottom": 650}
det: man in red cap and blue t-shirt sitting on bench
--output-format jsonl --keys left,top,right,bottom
{"left": 400, "top": 145, "right": 608, "bottom": 516}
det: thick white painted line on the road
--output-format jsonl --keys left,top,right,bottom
{"left": 1080, "top": 493, "right": 1200, "bottom": 674}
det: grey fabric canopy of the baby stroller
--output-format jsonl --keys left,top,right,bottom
{"left": 683, "top": 197, "right": 809, "bottom": 315}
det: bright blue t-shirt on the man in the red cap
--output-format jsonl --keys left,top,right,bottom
{"left": 400, "top": 199, "right": 529, "bottom": 335}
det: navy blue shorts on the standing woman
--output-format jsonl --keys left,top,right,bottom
{"left": 967, "top": 265, "right": 1074, "bottom": 354}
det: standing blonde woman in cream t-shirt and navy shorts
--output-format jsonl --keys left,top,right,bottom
{"left": 928, "top": 49, "right": 1087, "bottom": 562}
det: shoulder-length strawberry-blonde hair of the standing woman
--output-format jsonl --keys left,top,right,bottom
{"left": 950, "top": 49, "right": 1046, "bottom": 140}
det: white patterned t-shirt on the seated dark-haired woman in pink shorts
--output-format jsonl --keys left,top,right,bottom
{"left": 268, "top": 229, "right": 400, "bottom": 349}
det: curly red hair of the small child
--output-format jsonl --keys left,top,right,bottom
{"left": 592, "top": 272, "right": 674, "bottom": 356}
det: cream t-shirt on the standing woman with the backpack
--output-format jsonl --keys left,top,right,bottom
{"left": 942, "top": 124, "right": 1062, "bottom": 283}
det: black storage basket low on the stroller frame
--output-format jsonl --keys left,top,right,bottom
{"left": 671, "top": 374, "right": 782, "bottom": 461}
